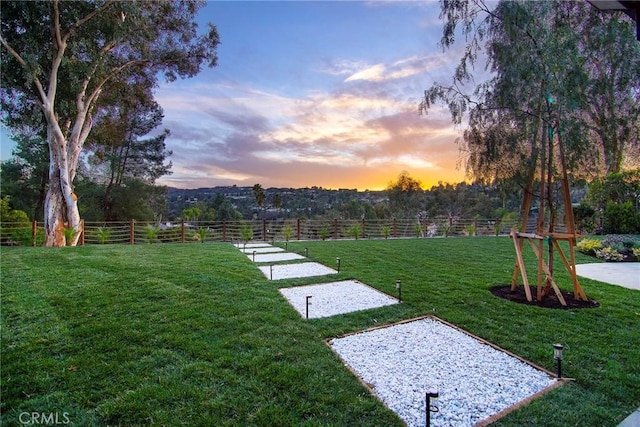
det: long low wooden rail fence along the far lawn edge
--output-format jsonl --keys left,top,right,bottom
{"left": 0, "top": 218, "right": 516, "bottom": 246}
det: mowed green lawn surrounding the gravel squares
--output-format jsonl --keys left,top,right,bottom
{"left": 0, "top": 237, "right": 640, "bottom": 426}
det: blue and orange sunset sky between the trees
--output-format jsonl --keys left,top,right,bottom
{"left": 0, "top": 1, "right": 484, "bottom": 190}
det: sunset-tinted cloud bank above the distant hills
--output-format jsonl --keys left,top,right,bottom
{"left": 154, "top": 46, "right": 464, "bottom": 189}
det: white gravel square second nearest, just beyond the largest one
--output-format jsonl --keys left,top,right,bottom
{"left": 279, "top": 280, "right": 398, "bottom": 319}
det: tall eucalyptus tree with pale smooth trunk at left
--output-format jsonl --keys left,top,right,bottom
{"left": 0, "top": 0, "right": 219, "bottom": 246}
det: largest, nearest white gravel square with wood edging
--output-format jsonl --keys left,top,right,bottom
{"left": 329, "top": 318, "right": 556, "bottom": 426}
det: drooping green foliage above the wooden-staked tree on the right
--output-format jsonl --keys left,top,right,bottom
{"left": 420, "top": 0, "right": 640, "bottom": 185}
